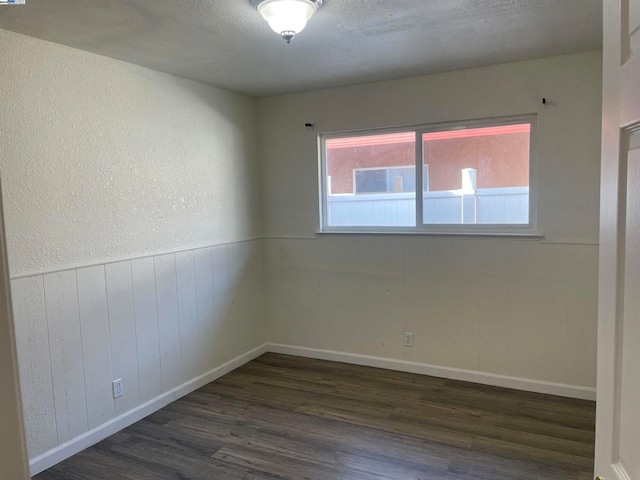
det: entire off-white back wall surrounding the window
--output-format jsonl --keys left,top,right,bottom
{"left": 259, "top": 52, "right": 601, "bottom": 387}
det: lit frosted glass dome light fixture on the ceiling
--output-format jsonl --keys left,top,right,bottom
{"left": 251, "top": 0, "right": 323, "bottom": 43}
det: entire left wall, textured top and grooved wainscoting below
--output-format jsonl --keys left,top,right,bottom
{"left": 0, "top": 31, "right": 265, "bottom": 472}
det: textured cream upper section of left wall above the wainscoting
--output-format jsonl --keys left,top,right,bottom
{"left": 0, "top": 31, "right": 260, "bottom": 275}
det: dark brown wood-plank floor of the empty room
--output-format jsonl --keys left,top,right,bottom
{"left": 34, "top": 354, "right": 595, "bottom": 480}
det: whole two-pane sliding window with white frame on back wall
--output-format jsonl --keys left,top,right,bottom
{"left": 320, "top": 116, "right": 535, "bottom": 234}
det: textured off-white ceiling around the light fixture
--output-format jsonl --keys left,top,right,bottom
{"left": 0, "top": 0, "right": 602, "bottom": 96}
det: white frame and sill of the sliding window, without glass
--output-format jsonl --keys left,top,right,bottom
{"left": 318, "top": 114, "right": 542, "bottom": 237}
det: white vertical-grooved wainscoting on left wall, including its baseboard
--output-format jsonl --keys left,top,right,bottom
{"left": 12, "top": 240, "right": 266, "bottom": 474}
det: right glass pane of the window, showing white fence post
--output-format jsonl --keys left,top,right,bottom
{"left": 422, "top": 123, "right": 531, "bottom": 225}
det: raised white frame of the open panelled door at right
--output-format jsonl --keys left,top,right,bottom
{"left": 595, "top": 0, "right": 640, "bottom": 480}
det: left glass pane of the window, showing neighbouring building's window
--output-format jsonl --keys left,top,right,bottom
{"left": 325, "top": 132, "right": 416, "bottom": 227}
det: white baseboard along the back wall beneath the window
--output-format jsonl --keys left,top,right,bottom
{"left": 266, "top": 343, "right": 596, "bottom": 401}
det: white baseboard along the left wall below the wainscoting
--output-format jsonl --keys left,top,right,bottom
{"left": 29, "top": 344, "right": 268, "bottom": 476}
